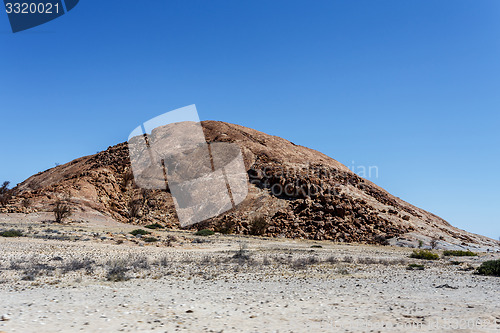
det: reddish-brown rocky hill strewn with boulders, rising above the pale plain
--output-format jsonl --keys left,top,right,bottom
{"left": 2, "top": 121, "right": 498, "bottom": 248}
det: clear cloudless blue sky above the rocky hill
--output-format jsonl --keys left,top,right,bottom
{"left": 0, "top": 0, "right": 500, "bottom": 238}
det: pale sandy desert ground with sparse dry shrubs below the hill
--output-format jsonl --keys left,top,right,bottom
{"left": 0, "top": 213, "right": 500, "bottom": 333}
